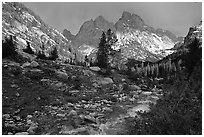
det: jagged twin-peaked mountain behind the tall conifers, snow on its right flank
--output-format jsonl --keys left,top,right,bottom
{"left": 69, "top": 11, "right": 180, "bottom": 61}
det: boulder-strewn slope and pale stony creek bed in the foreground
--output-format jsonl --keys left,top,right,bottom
{"left": 2, "top": 60, "right": 162, "bottom": 135}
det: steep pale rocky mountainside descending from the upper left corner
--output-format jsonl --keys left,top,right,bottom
{"left": 2, "top": 2, "right": 72, "bottom": 59}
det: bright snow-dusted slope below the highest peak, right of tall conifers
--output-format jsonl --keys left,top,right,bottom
{"left": 116, "top": 28, "right": 175, "bottom": 59}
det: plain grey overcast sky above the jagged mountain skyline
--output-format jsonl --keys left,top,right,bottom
{"left": 24, "top": 2, "right": 202, "bottom": 36}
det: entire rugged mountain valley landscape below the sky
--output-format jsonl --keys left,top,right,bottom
{"left": 2, "top": 2, "right": 202, "bottom": 135}
